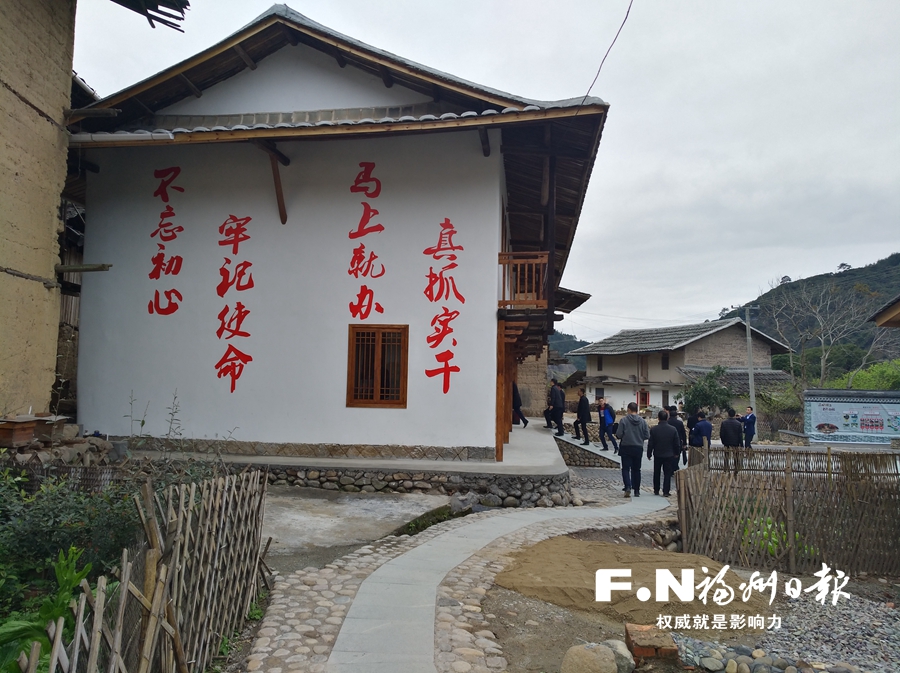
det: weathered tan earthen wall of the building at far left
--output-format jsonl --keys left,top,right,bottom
{"left": 0, "top": 0, "right": 75, "bottom": 414}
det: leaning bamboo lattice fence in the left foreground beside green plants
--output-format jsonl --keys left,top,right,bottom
{"left": 18, "top": 470, "right": 267, "bottom": 673}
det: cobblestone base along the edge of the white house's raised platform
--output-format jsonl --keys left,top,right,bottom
{"left": 256, "top": 466, "right": 574, "bottom": 507}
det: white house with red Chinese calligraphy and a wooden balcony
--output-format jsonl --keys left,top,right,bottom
{"left": 71, "top": 5, "right": 608, "bottom": 461}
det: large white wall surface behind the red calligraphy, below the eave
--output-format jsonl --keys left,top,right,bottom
{"left": 79, "top": 132, "right": 502, "bottom": 446}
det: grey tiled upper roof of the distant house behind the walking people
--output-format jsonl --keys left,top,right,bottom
{"left": 566, "top": 318, "right": 790, "bottom": 355}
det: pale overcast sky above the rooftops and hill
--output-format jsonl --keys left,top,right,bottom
{"left": 74, "top": 0, "right": 900, "bottom": 341}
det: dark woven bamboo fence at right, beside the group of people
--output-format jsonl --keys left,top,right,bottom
{"left": 676, "top": 448, "right": 900, "bottom": 575}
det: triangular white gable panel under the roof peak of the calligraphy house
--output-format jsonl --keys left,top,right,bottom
{"left": 163, "top": 45, "right": 431, "bottom": 115}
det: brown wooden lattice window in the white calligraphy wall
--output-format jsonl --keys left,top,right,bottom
{"left": 347, "top": 325, "right": 409, "bottom": 409}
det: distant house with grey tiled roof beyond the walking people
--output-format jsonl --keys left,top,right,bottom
{"left": 567, "top": 318, "right": 790, "bottom": 409}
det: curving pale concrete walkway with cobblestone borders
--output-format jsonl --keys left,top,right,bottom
{"left": 245, "top": 485, "right": 671, "bottom": 673}
